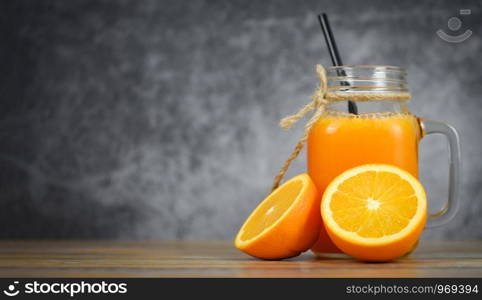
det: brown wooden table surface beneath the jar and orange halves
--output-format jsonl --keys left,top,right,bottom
{"left": 0, "top": 241, "right": 482, "bottom": 277}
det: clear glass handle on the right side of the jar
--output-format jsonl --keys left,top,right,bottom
{"left": 420, "top": 119, "right": 462, "bottom": 228}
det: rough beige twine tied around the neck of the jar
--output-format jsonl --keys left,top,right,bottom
{"left": 271, "top": 65, "right": 411, "bottom": 191}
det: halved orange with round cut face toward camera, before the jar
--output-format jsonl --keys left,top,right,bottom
{"left": 321, "top": 164, "right": 427, "bottom": 261}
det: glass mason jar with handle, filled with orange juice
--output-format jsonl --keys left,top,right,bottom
{"left": 307, "top": 66, "right": 461, "bottom": 254}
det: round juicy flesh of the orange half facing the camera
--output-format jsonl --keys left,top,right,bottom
{"left": 330, "top": 171, "right": 418, "bottom": 238}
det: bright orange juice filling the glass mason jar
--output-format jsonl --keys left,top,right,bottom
{"left": 307, "top": 113, "right": 421, "bottom": 253}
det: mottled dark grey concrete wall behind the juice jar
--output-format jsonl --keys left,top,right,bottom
{"left": 0, "top": 0, "right": 482, "bottom": 239}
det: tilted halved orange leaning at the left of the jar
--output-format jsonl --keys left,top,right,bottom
{"left": 234, "top": 174, "right": 321, "bottom": 259}
